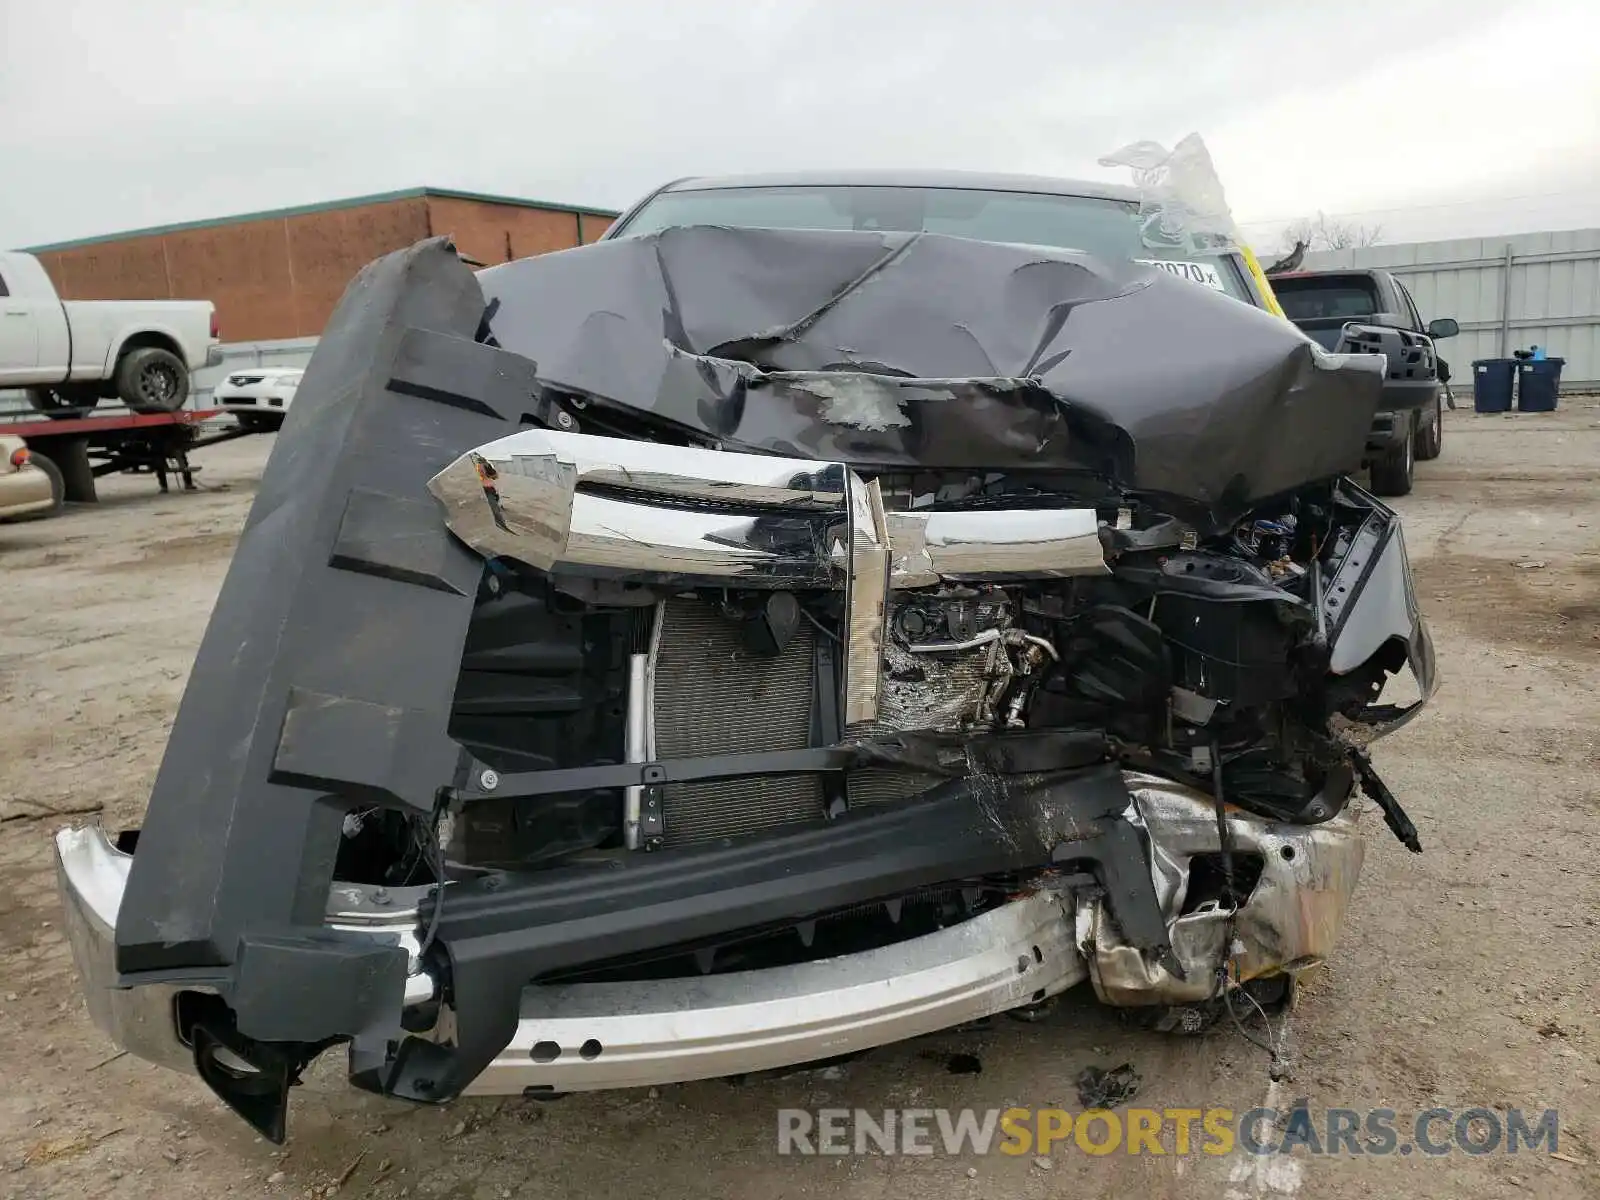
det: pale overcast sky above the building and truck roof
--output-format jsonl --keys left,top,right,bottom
{"left": 0, "top": 0, "right": 1600, "bottom": 250}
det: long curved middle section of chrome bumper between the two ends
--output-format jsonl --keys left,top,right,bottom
{"left": 467, "top": 891, "right": 1086, "bottom": 1094}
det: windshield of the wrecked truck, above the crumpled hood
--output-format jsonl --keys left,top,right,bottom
{"left": 613, "top": 186, "right": 1254, "bottom": 304}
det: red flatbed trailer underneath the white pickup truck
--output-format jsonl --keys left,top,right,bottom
{"left": 0, "top": 408, "right": 256, "bottom": 504}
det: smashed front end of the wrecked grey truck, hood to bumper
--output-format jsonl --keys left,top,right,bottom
{"left": 56, "top": 173, "right": 1434, "bottom": 1139}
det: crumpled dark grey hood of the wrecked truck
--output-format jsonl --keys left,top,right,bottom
{"left": 478, "top": 227, "right": 1382, "bottom": 525}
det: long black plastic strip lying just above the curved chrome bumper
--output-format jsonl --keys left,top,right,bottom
{"left": 380, "top": 765, "right": 1170, "bottom": 1101}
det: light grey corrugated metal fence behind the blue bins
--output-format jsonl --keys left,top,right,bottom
{"left": 1304, "top": 229, "right": 1600, "bottom": 392}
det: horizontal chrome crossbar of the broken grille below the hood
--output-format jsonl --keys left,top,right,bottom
{"left": 429, "top": 429, "right": 1109, "bottom": 594}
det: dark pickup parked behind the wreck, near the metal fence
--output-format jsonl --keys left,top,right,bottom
{"left": 1270, "top": 270, "right": 1461, "bottom": 496}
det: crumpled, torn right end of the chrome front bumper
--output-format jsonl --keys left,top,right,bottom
{"left": 1077, "top": 774, "right": 1366, "bottom": 1006}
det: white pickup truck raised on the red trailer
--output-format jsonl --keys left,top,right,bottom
{"left": 0, "top": 250, "right": 222, "bottom": 418}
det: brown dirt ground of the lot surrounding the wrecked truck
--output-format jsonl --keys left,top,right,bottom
{"left": 0, "top": 402, "right": 1600, "bottom": 1200}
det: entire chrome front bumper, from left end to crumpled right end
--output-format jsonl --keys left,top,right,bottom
{"left": 56, "top": 774, "right": 1363, "bottom": 1094}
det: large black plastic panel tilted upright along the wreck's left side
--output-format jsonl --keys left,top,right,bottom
{"left": 117, "top": 238, "right": 524, "bottom": 1004}
